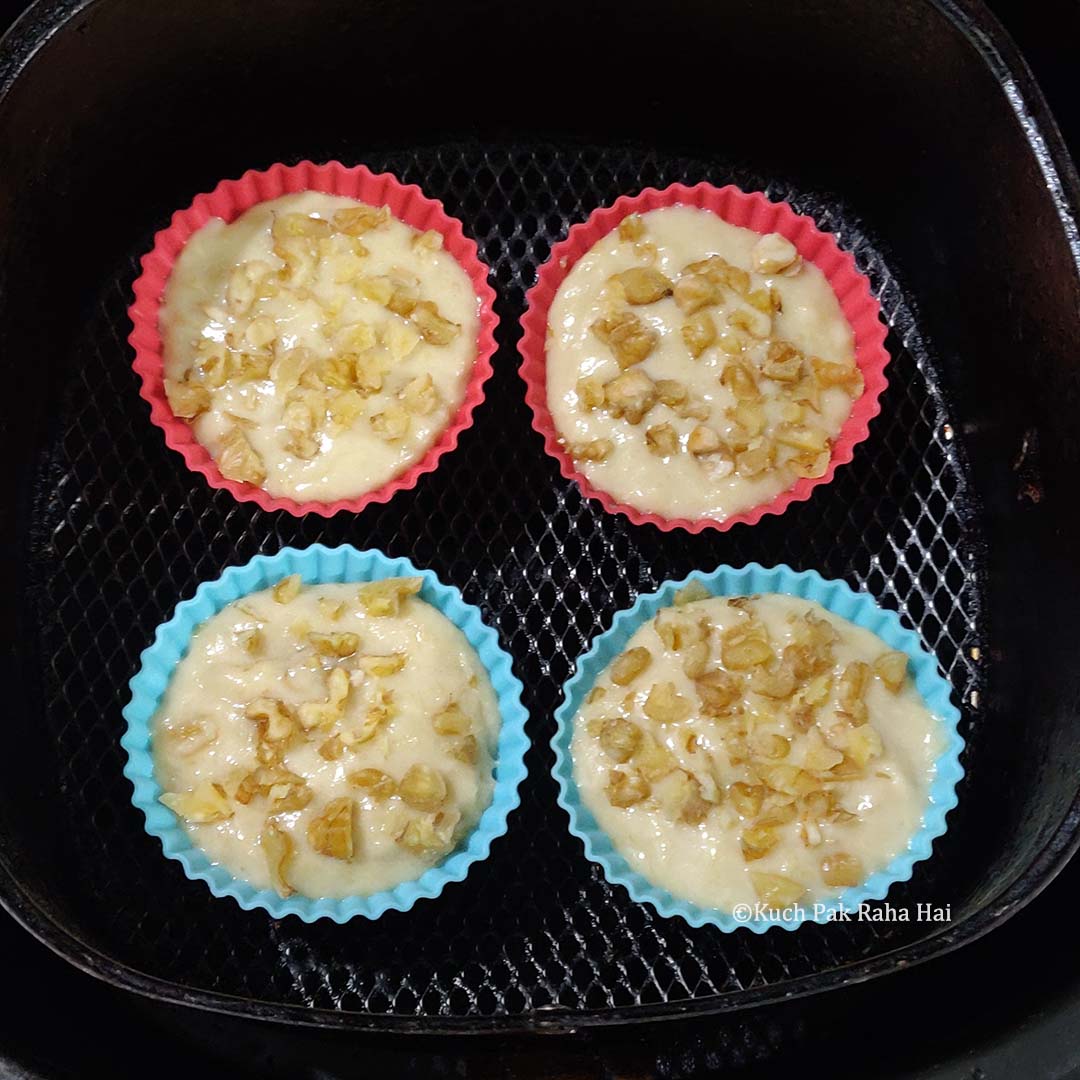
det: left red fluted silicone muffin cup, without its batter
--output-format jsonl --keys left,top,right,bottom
{"left": 127, "top": 161, "right": 497, "bottom": 517}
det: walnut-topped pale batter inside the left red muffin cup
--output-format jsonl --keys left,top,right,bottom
{"left": 160, "top": 191, "right": 480, "bottom": 501}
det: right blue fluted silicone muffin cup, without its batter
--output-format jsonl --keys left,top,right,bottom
{"left": 552, "top": 563, "right": 963, "bottom": 933}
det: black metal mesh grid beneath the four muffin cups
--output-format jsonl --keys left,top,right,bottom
{"left": 29, "top": 145, "right": 985, "bottom": 1018}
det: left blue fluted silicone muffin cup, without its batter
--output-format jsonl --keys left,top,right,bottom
{"left": 120, "top": 544, "right": 529, "bottom": 922}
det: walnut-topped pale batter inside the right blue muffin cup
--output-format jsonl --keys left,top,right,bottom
{"left": 571, "top": 594, "right": 944, "bottom": 912}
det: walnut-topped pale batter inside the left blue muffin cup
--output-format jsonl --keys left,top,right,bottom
{"left": 152, "top": 579, "right": 499, "bottom": 897}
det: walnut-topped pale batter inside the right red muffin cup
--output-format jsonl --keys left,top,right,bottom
{"left": 546, "top": 206, "right": 862, "bottom": 521}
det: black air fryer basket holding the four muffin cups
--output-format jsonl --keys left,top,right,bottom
{"left": 0, "top": 0, "right": 1080, "bottom": 1031}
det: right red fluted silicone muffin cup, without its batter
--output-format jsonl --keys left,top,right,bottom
{"left": 518, "top": 184, "right": 889, "bottom": 532}
